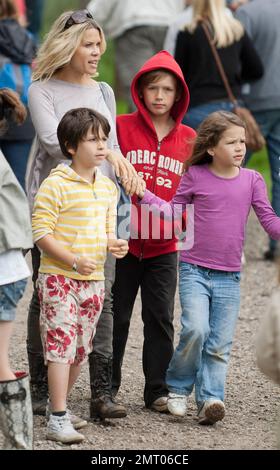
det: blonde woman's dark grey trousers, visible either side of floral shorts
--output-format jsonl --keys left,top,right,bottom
{"left": 27, "top": 246, "right": 116, "bottom": 368}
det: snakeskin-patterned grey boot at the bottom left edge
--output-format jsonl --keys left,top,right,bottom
{"left": 0, "top": 372, "right": 33, "bottom": 450}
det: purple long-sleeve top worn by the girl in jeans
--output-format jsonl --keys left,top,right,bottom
{"left": 140, "top": 165, "right": 280, "bottom": 271}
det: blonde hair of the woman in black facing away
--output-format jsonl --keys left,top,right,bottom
{"left": 185, "top": 0, "right": 244, "bottom": 47}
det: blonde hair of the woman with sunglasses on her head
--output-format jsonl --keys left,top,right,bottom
{"left": 32, "top": 11, "right": 106, "bottom": 80}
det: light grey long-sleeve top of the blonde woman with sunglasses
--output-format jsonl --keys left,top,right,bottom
{"left": 27, "top": 79, "right": 119, "bottom": 208}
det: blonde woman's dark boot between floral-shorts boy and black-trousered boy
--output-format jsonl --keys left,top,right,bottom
{"left": 89, "top": 353, "right": 127, "bottom": 420}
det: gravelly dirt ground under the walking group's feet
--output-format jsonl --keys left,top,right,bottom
{"left": 0, "top": 211, "right": 279, "bottom": 450}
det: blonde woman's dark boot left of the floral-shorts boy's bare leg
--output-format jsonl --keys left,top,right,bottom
{"left": 28, "top": 351, "right": 49, "bottom": 416}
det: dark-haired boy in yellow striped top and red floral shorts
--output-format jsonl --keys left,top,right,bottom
{"left": 32, "top": 108, "right": 128, "bottom": 443}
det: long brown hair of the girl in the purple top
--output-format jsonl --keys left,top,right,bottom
{"left": 184, "top": 111, "right": 246, "bottom": 171}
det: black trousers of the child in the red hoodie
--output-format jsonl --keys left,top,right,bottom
{"left": 112, "top": 253, "right": 177, "bottom": 407}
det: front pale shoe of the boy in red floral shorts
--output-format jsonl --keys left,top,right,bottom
{"left": 46, "top": 413, "right": 85, "bottom": 444}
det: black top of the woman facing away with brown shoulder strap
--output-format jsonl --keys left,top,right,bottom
{"left": 175, "top": 25, "right": 264, "bottom": 107}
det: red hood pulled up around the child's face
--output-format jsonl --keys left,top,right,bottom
{"left": 131, "top": 51, "right": 190, "bottom": 132}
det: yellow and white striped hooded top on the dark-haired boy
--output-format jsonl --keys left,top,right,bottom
{"left": 32, "top": 164, "right": 118, "bottom": 281}
